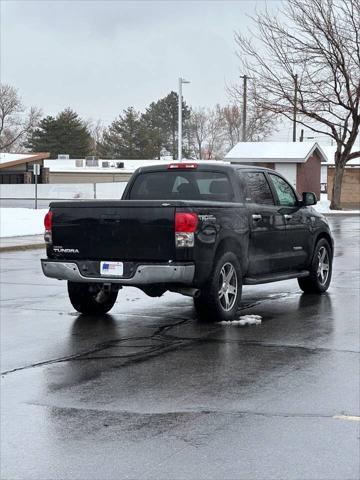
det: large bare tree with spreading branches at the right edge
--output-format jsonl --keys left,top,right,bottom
{"left": 235, "top": 0, "right": 360, "bottom": 209}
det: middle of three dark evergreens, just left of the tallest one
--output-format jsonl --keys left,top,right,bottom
{"left": 99, "top": 107, "right": 146, "bottom": 159}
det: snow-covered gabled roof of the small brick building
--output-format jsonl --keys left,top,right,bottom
{"left": 225, "top": 142, "right": 327, "bottom": 163}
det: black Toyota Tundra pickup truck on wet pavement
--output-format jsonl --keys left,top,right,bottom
{"left": 41, "top": 162, "right": 333, "bottom": 321}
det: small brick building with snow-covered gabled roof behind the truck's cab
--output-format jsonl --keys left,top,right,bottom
{"left": 224, "top": 142, "right": 327, "bottom": 198}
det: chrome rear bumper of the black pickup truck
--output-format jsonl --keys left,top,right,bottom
{"left": 41, "top": 260, "right": 195, "bottom": 286}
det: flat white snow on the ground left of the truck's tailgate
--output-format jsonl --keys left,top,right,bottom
{"left": 0, "top": 208, "right": 48, "bottom": 237}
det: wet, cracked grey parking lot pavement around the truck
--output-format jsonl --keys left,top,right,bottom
{"left": 1, "top": 216, "right": 360, "bottom": 480}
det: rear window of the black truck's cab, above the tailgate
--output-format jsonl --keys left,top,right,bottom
{"left": 129, "top": 170, "right": 234, "bottom": 202}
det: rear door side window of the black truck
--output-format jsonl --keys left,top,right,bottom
{"left": 239, "top": 172, "right": 274, "bottom": 205}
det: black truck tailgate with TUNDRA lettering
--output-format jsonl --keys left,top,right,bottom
{"left": 50, "top": 200, "right": 175, "bottom": 262}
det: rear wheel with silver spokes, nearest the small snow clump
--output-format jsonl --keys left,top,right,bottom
{"left": 194, "top": 252, "right": 242, "bottom": 322}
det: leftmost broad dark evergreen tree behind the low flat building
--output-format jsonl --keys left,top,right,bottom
{"left": 27, "top": 108, "right": 91, "bottom": 158}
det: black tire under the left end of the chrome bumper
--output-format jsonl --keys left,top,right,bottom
{"left": 68, "top": 282, "right": 118, "bottom": 315}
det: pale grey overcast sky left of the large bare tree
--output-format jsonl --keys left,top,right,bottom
{"left": 1, "top": 0, "right": 278, "bottom": 117}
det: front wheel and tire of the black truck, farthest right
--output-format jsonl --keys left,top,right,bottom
{"left": 298, "top": 238, "right": 332, "bottom": 294}
